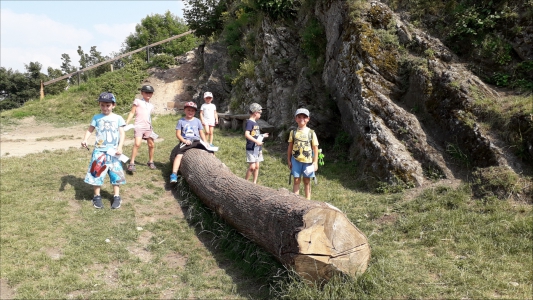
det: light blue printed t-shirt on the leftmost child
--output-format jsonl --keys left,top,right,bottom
{"left": 91, "top": 113, "right": 126, "bottom": 151}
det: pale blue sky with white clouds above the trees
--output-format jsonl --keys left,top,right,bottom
{"left": 0, "top": 0, "right": 185, "bottom": 74}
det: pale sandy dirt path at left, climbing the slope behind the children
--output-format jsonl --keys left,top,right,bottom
{"left": 0, "top": 52, "right": 198, "bottom": 157}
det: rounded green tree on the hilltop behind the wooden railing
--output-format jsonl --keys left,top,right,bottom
{"left": 124, "top": 11, "right": 196, "bottom": 56}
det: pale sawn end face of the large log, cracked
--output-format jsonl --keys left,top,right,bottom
{"left": 294, "top": 208, "right": 370, "bottom": 281}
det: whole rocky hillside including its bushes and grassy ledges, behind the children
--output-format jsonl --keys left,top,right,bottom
{"left": 186, "top": 1, "right": 533, "bottom": 198}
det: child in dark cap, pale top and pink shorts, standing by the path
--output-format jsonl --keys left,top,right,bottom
{"left": 126, "top": 85, "right": 156, "bottom": 172}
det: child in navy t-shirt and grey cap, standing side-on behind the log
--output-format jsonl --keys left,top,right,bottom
{"left": 244, "top": 103, "right": 268, "bottom": 183}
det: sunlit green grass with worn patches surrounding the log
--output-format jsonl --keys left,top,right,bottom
{"left": 0, "top": 110, "right": 533, "bottom": 299}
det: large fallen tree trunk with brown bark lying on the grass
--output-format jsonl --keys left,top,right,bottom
{"left": 170, "top": 148, "right": 370, "bottom": 281}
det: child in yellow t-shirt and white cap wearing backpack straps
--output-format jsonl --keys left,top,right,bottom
{"left": 287, "top": 108, "right": 318, "bottom": 200}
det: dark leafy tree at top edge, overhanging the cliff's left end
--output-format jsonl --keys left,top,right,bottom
{"left": 183, "top": 0, "right": 226, "bottom": 38}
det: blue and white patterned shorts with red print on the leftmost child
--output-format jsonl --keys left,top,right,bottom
{"left": 84, "top": 149, "right": 126, "bottom": 186}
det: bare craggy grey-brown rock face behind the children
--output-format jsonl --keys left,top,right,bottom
{"left": 189, "top": 1, "right": 533, "bottom": 185}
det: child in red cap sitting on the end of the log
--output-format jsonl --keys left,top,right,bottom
{"left": 170, "top": 102, "right": 211, "bottom": 182}
